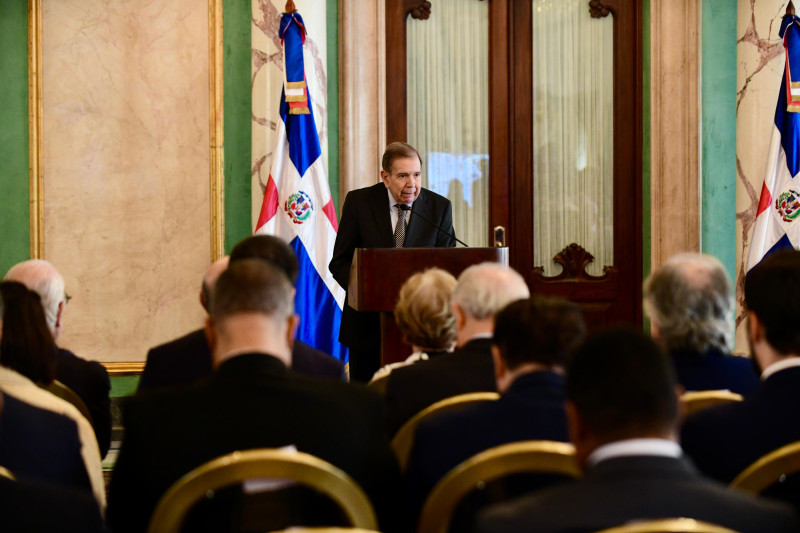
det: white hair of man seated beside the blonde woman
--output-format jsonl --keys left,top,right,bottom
{"left": 451, "top": 263, "right": 530, "bottom": 320}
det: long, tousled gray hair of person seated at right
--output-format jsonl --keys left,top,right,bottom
{"left": 644, "top": 253, "right": 734, "bottom": 352}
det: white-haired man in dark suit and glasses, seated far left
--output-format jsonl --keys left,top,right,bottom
{"left": 5, "top": 259, "right": 111, "bottom": 457}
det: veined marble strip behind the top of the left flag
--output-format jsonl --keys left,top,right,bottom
{"left": 251, "top": 0, "right": 326, "bottom": 228}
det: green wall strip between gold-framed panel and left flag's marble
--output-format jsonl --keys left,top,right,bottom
{"left": 222, "top": 0, "right": 253, "bottom": 253}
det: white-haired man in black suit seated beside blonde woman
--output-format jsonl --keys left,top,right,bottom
{"left": 386, "top": 263, "right": 530, "bottom": 435}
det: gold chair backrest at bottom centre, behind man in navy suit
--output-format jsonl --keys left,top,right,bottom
{"left": 417, "top": 441, "right": 580, "bottom": 533}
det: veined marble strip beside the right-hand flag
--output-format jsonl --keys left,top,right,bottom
{"left": 735, "top": 0, "right": 787, "bottom": 352}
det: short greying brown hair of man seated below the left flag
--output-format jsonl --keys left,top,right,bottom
{"left": 209, "top": 259, "right": 294, "bottom": 323}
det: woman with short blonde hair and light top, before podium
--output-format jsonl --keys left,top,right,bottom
{"left": 372, "top": 268, "right": 456, "bottom": 380}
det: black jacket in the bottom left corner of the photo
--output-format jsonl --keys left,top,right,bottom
{"left": 0, "top": 477, "right": 105, "bottom": 533}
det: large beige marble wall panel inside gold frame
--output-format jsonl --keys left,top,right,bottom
{"left": 42, "top": 0, "right": 211, "bottom": 361}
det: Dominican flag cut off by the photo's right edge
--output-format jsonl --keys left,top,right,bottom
{"left": 746, "top": 14, "right": 800, "bottom": 272}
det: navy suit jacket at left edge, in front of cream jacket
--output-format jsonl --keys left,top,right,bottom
{"left": 0, "top": 388, "right": 92, "bottom": 492}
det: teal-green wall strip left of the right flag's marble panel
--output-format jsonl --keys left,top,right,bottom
{"left": 701, "top": 0, "right": 736, "bottom": 279}
